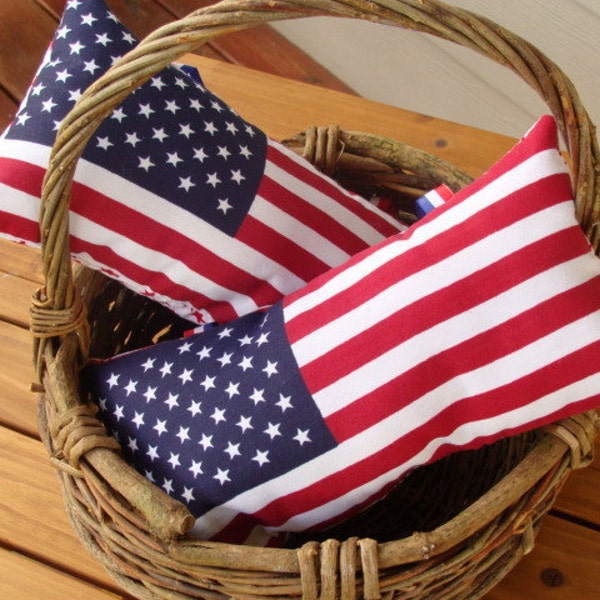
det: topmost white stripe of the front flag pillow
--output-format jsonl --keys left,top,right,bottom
{"left": 285, "top": 150, "right": 567, "bottom": 322}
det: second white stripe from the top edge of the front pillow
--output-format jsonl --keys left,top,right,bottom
{"left": 292, "top": 201, "right": 574, "bottom": 366}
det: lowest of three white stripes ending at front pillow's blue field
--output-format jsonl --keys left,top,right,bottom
{"left": 313, "top": 254, "right": 598, "bottom": 417}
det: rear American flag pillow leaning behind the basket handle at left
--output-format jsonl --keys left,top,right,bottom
{"left": 0, "top": 0, "right": 401, "bottom": 323}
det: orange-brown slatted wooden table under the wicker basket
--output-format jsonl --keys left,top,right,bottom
{"left": 0, "top": 57, "right": 600, "bottom": 600}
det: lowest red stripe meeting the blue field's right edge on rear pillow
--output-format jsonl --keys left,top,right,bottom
{"left": 236, "top": 214, "right": 329, "bottom": 282}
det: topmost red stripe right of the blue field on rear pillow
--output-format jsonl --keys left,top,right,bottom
{"left": 267, "top": 144, "right": 400, "bottom": 237}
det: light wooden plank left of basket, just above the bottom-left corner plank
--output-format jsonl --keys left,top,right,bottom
{"left": 0, "top": 428, "right": 125, "bottom": 598}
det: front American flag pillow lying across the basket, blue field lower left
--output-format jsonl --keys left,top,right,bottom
{"left": 83, "top": 117, "right": 600, "bottom": 543}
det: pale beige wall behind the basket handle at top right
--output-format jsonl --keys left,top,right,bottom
{"left": 275, "top": 0, "right": 600, "bottom": 137}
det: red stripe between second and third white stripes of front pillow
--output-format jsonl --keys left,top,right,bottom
{"left": 301, "top": 226, "right": 582, "bottom": 394}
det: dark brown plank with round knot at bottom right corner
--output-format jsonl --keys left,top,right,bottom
{"left": 485, "top": 516, "right": 600, "bottom": 600}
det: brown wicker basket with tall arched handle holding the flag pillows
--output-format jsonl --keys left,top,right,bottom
{"left": 32, "top": 0, "right": 600, "bottom": 599}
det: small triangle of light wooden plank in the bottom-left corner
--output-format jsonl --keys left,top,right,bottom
{"left": 0, "top": 548, "right": 125, "bottom": 600}
